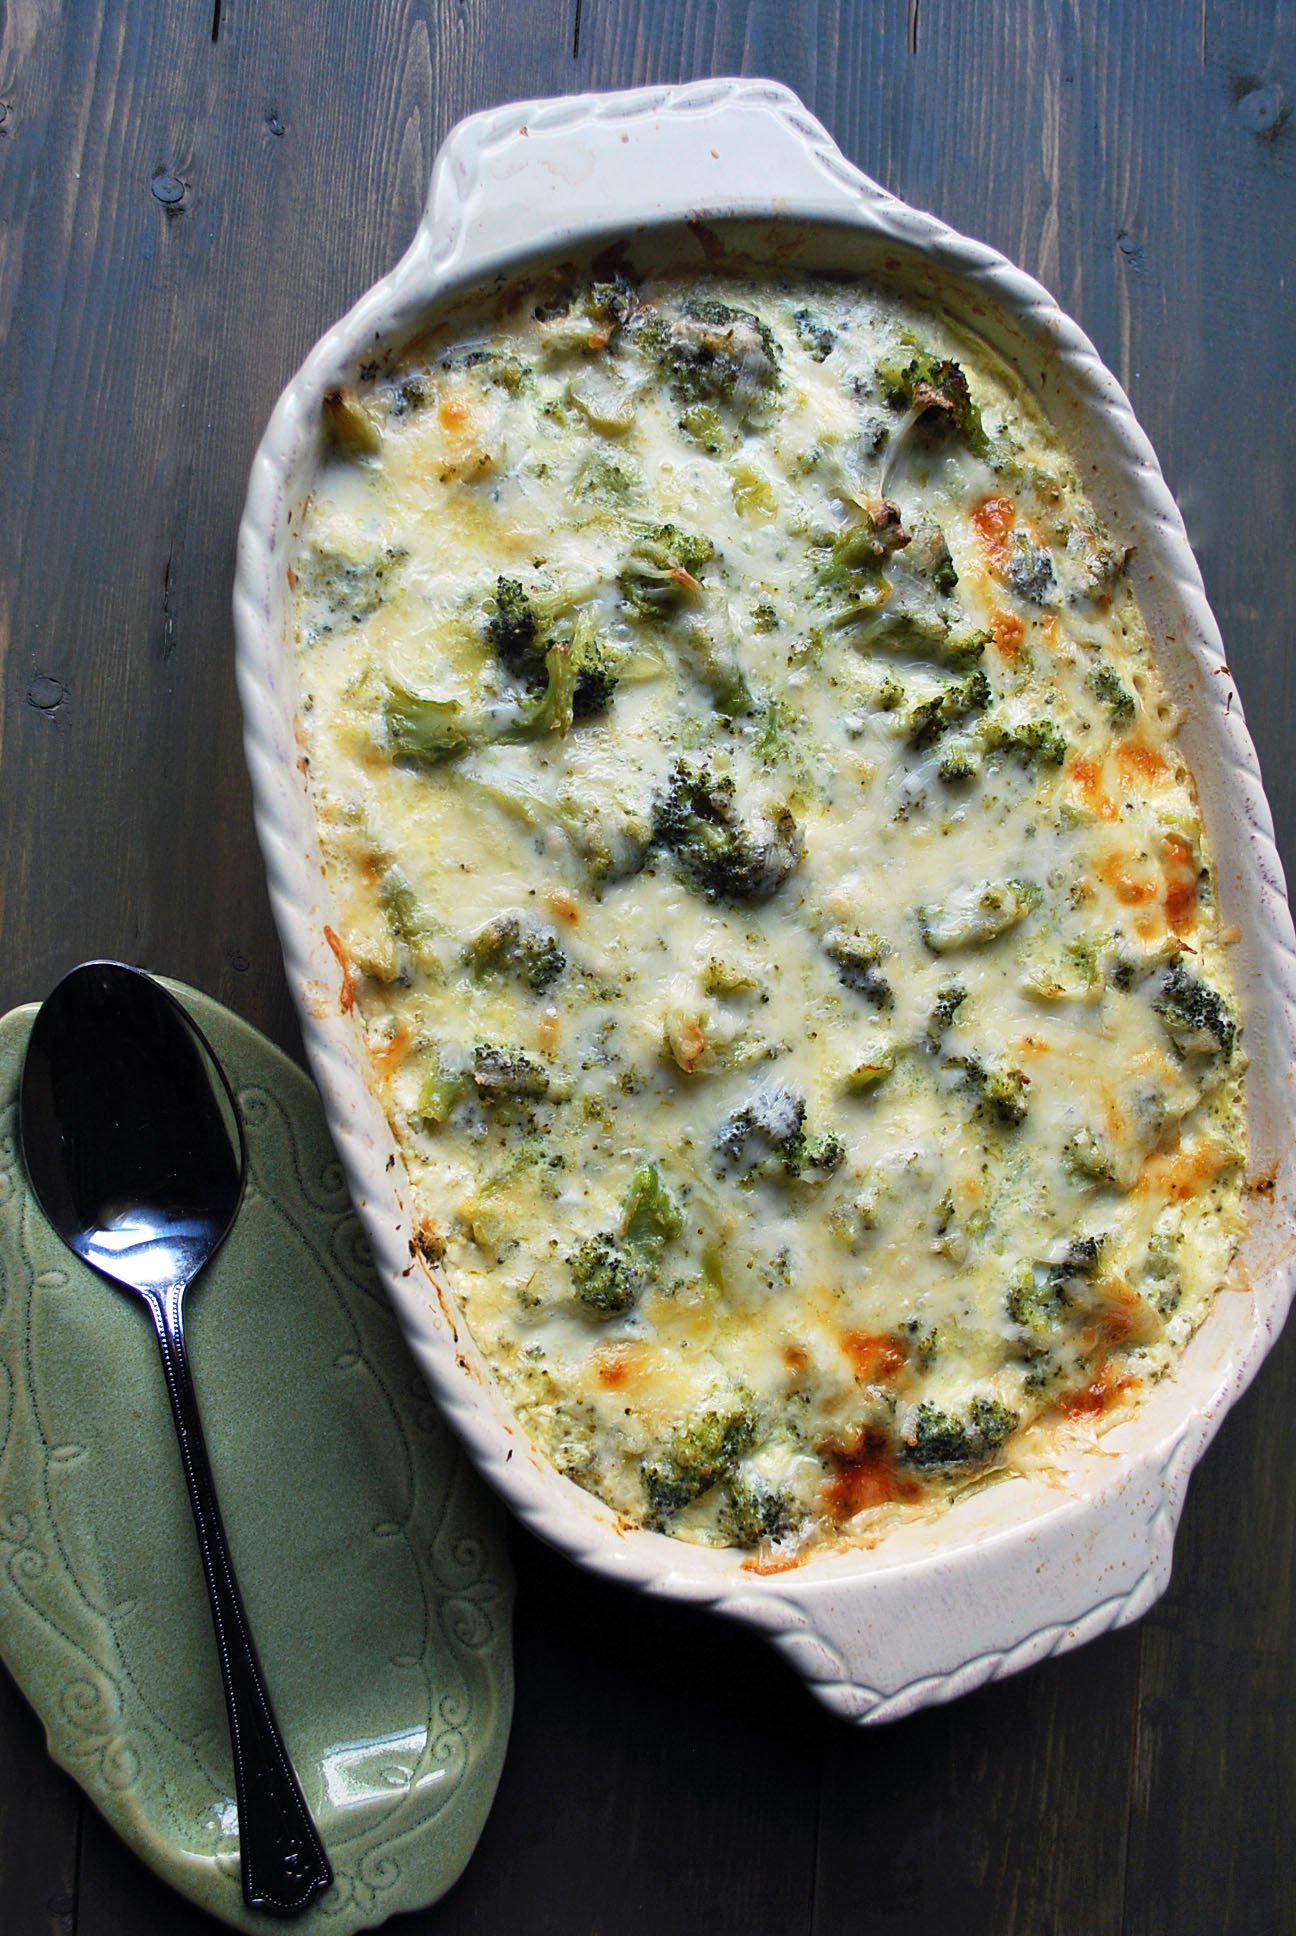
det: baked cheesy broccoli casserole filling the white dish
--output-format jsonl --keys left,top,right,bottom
{"left": 293, "top": 279, "right": 1246, "bottom": 1564}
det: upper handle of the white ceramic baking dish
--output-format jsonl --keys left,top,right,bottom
{"left": 415, "top": 79, "right": 901, "bottom": 277}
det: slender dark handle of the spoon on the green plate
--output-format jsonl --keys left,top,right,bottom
{"left": 147, "top": 1286, "right": 333, "bottom": 1917}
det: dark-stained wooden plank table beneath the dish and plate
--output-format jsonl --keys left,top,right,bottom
{"left": 0, "top": 0, "right": 1296, "bottom": 1936}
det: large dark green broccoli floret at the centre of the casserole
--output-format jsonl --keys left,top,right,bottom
{"left": 653, "top": 759, "right": 802, "bottom": 902}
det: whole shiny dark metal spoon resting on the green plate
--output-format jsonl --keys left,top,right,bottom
{"left": 17, "top": 962, "right": 333, "bottom": 1917}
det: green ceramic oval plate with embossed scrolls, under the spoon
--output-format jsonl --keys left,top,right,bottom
{"left": 0, "top": 987, "right": 511, "bottom": 1936}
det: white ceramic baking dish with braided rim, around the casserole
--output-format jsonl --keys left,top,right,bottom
{"left": 234, "top": 79, "right": 1296, "bottom": 1721}
